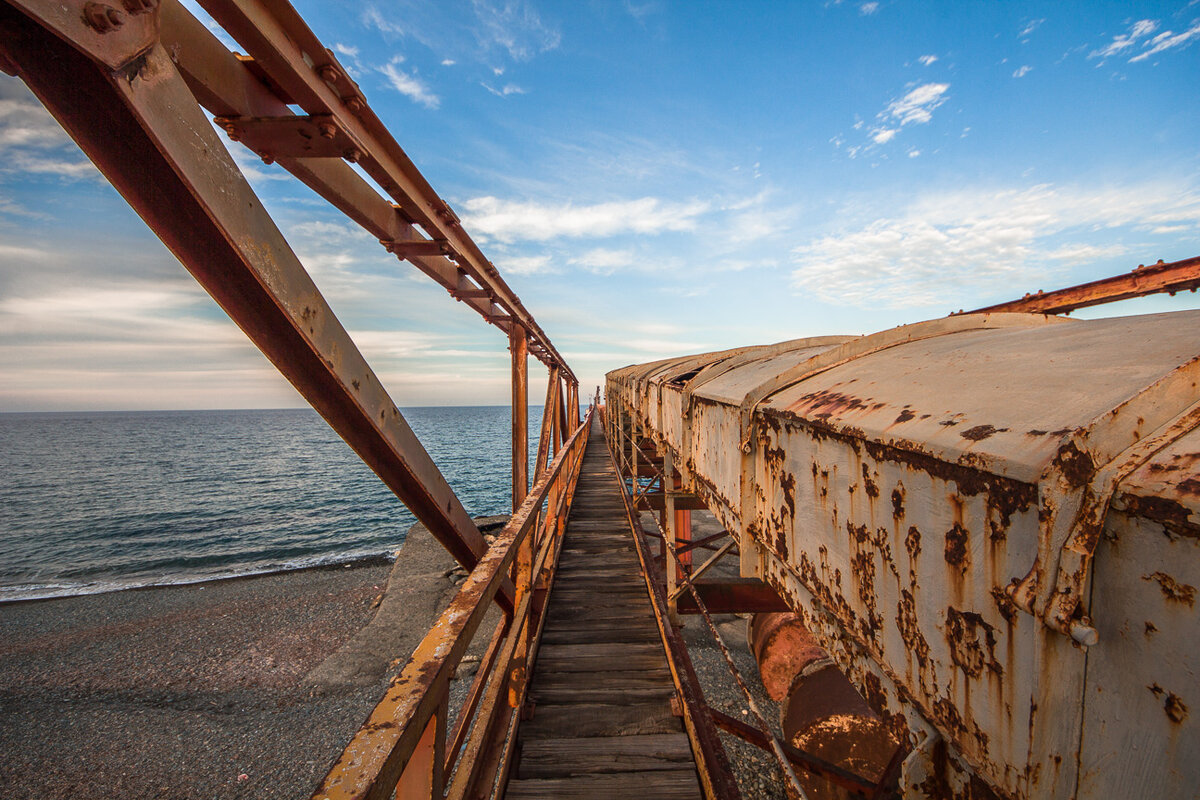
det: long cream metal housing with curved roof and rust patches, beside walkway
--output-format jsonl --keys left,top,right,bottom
{"left": 608, "top": 312, "right": 1200, "bottom": 798}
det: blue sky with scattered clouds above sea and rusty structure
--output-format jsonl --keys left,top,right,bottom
{"left": 0, "top": 0, "right": 1200, "bottom": 411}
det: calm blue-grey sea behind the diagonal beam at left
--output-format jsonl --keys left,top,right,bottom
{"left": 0, "top": 403, "right": 541, "bottom": 601}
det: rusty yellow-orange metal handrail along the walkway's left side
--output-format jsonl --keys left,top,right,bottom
{"left": 312, "top": 410, "right": 593, "bottom": 800}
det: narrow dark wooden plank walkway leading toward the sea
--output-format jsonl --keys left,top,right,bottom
{"left": 505, "top": 425, "right": 703, "bottom": 800}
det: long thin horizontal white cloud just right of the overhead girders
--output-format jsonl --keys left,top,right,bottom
{"left": 463, "top": 197, "right": 708, "bottom": 242}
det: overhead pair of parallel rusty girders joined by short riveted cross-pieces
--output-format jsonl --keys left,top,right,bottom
{"left": 177, "top": 0, "right": 575, "bottom": 380}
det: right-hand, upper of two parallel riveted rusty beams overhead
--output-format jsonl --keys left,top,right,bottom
{"left": 190, "top": 0, "right": 575, "bottom": 380}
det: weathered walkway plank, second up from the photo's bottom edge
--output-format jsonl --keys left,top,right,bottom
{"left": 517, "top": 733, "right": 692, "bottom": 778}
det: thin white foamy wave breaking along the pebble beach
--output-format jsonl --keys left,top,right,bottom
{"left": 0, "top": 548, "right": 396, "bottom": 603}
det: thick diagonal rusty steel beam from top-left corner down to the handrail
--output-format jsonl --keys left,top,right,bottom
{"left": 0, "top": 2, "right": 511, "bottom": 585}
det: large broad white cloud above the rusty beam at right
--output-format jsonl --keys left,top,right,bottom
{"left": 792, "top": 182, "right": 1200, "bottom": 308}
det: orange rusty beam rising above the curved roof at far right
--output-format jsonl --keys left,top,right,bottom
{"left": 952, "top": 255, "right": 1200, "bottom": 315}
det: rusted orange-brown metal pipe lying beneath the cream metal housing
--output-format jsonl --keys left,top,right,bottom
{"left": 746, "top": 613, "right": 899, "bottom": 800}
